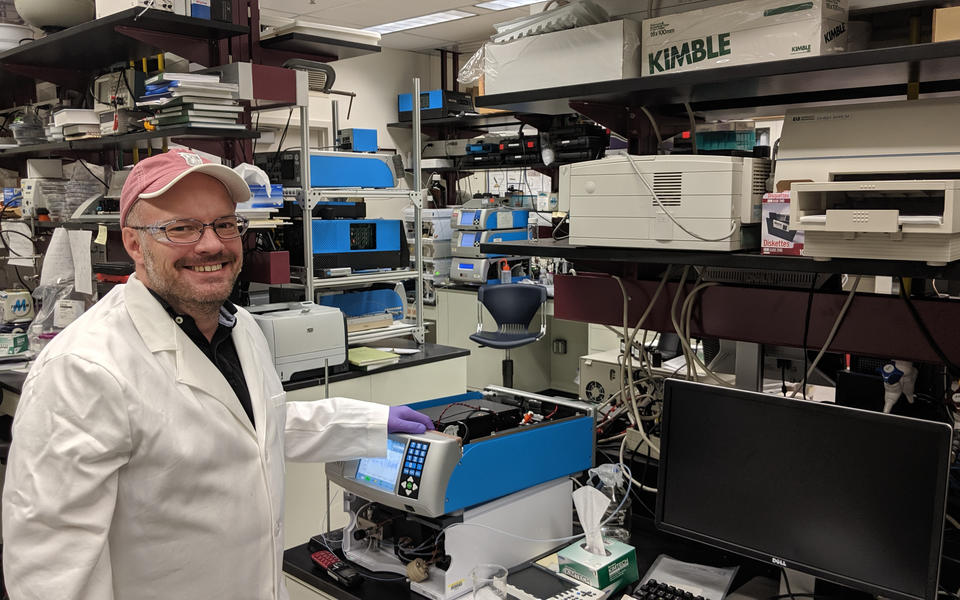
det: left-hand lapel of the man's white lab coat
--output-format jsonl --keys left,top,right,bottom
{"left": 124, "top": 275, "right": 256, "bottom": 436}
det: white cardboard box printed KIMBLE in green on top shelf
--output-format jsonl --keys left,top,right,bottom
{"left": 641, "top": 0, "right": 847, "bottom": 76}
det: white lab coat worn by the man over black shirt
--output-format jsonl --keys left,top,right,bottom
{"left": 3, "top": 278, "right": 388, "bottom": 600}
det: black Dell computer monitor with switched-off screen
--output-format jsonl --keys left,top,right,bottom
{"left": 656, "top": 380, "right": 952, "bottom": 600}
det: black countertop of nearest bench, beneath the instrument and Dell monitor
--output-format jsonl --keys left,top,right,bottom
{"left": 283, "top": 519, "right": 779, "bottom": 600}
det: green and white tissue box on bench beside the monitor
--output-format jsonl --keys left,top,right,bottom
{"left": 557, "top": 540, "right": 640, "bottom": 591}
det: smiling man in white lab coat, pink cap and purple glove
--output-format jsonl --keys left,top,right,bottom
{"left": 3, "top": 151, "right": 432, "bottom": 600}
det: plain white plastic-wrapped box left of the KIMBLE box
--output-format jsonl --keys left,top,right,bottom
{"left": 483, "top": 19, "right": 641, "bottom": 94}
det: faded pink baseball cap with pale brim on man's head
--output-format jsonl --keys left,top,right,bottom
{"left": 120, "top": 150, "right": 250, "bottom": 227}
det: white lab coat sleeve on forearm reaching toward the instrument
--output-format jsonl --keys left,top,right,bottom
{"left": 284, "top": 398, "right": 389, "bottom": 462}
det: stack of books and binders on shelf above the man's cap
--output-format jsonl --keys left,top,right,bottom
{"left": 138, "top": 73, "right": 246, "bottom": 129}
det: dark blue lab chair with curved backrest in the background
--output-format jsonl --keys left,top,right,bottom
{"left": 470, "top": 283, "right": 547, "bottom": 387}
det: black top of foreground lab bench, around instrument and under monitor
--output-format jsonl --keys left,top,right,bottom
{"left": 283, "top": 517, "right": 779, "bottom": 600}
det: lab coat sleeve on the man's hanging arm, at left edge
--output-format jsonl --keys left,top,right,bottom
{"left": 3, "top": 355, "right": 132, "bottom": 600}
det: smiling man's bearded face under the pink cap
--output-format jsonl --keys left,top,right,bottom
{"left": 123, "top": 173, "right": 243, "bottom": 314}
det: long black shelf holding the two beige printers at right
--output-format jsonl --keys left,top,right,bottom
{"left": 480, "top": 239, "right": 960, "bottom": 279}
